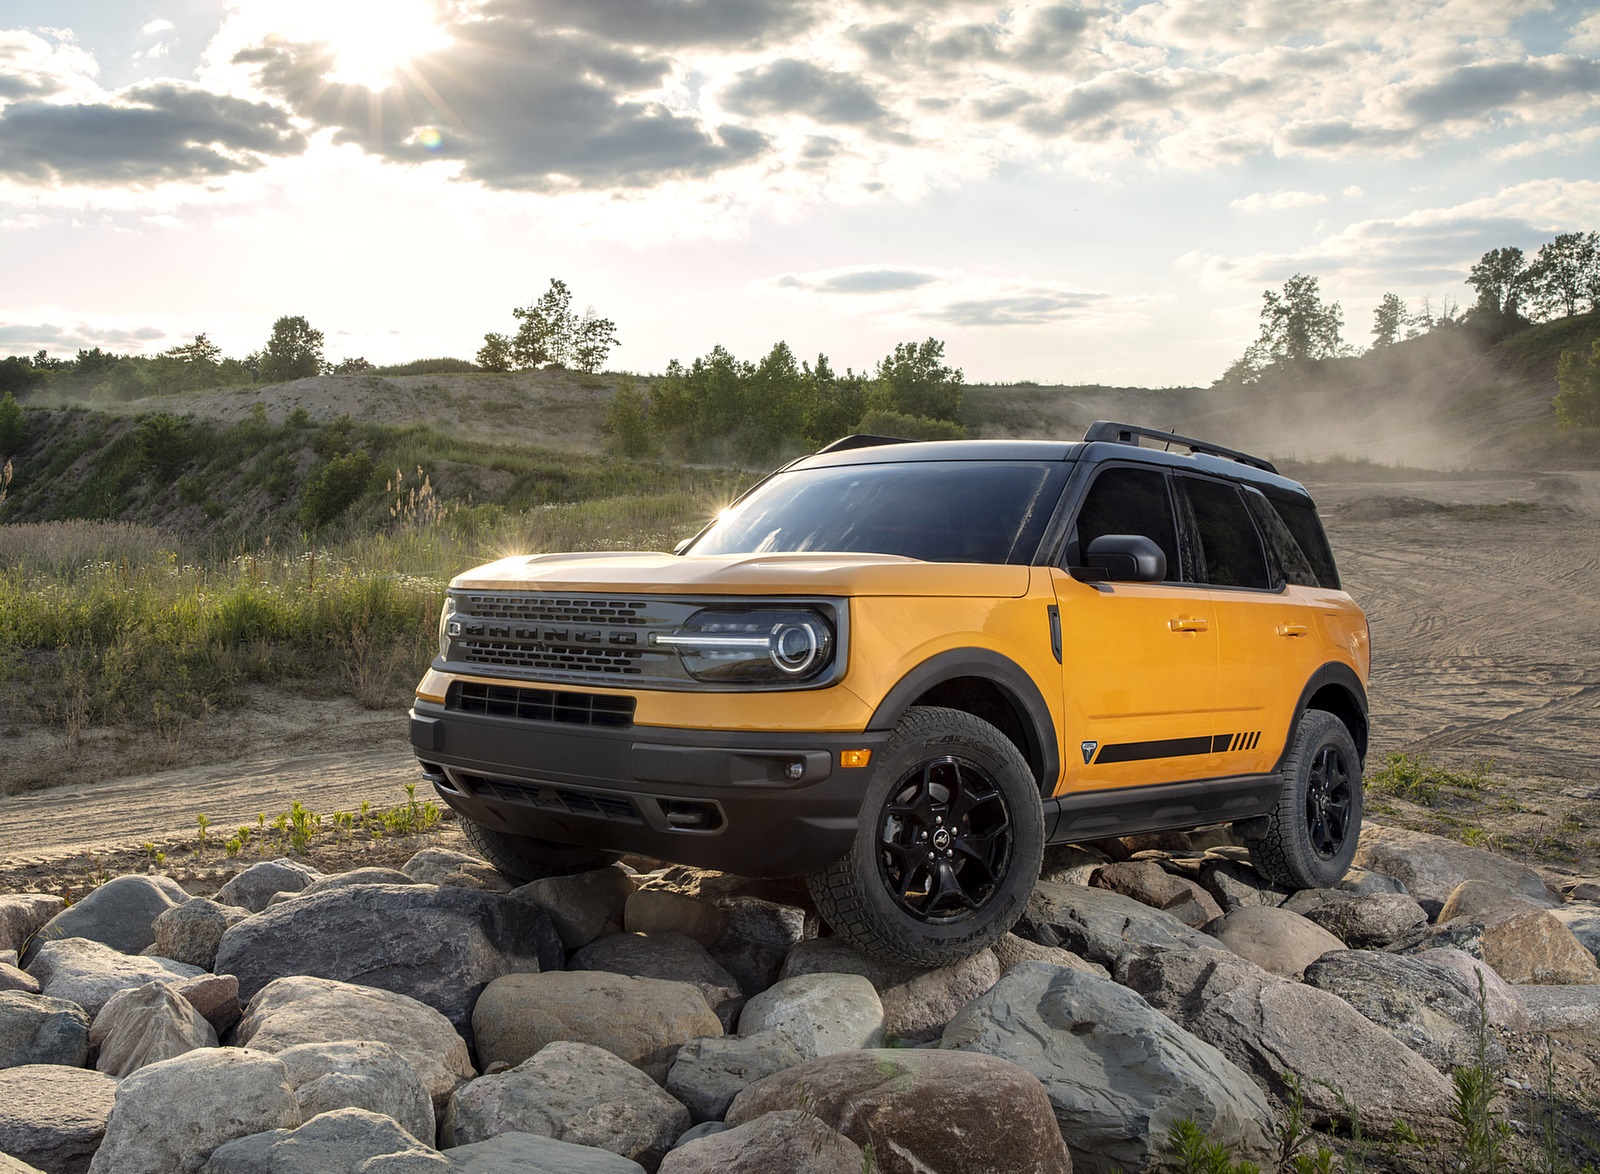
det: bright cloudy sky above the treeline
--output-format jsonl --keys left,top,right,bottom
{"left": 0, "top": 0, "right": 1600, "bottom": 387}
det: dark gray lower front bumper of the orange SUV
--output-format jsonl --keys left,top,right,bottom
{"left": 411, "top": 701, "right": 888, "bottom": 877}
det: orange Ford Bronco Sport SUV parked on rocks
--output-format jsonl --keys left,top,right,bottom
{"left": 411, "top": 422, "right": 1370, "bottom": 966}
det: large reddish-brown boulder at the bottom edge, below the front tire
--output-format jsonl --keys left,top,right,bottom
{"left": 728, "top": 1048, "right": 1072, "bottom": 1174}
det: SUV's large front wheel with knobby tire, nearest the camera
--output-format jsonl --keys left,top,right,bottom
{"left": 806, "top": 707, "right": 1045, "bottom": 969}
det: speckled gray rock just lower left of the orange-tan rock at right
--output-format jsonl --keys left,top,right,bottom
{"left": 1306, "top": 950, "right": 1506, "bottom": 1072}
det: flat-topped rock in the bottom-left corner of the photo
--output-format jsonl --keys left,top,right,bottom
{"left": 0, "top": 1064, "right": 117, "bottom": 1174}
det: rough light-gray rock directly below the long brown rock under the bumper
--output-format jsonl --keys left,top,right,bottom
{"left": 442, "top": 1041, "right": 690, "bottom": 1171}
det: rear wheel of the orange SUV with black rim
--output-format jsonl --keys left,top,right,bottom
{"left": 1242, "top": 709, "right": 1362, "bottom": 889}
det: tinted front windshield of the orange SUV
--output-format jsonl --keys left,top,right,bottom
{"left": 688, "top": 461, "right": 1070, "bottom": 563}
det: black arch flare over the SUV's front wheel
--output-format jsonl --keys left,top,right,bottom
{"left": 867, "top": 648, "right": 1061, "bottom": 806}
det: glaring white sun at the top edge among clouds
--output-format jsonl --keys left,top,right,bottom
{"left": 274, "top": 0, "right": 450, "bottom": 90}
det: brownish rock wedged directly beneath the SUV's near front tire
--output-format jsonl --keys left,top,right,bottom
{"left": 779, "top": 937, "right": 1002, "bottom": 1043}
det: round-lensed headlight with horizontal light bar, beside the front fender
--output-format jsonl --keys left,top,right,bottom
{"left": 650, "top": 608, "right": 834, "bottom": 685}
